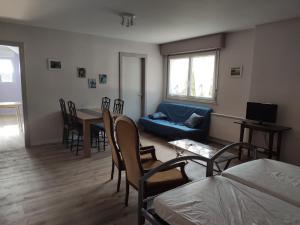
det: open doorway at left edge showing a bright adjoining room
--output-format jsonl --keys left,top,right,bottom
{"left": 0, "top": 42, "right": 25, "bottom": 151}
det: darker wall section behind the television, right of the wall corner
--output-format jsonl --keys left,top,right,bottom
{"left": 250, "top": 18, "right": 300, "bottom": 165}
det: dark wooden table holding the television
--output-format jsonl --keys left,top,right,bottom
{"left": 234, "top": 120, "right": 291, "bottom": 160}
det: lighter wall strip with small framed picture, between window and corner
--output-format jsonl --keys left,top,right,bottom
{"left": 209, "top": 29, "right": 255, "bottom": 141}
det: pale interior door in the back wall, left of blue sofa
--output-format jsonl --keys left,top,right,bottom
{"left": 119, "top": 52, "right": 147, "bottom": 121}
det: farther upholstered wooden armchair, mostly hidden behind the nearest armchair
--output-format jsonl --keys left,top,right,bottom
{"left": 103, "top": 110, "right": 156, "bottom": 192}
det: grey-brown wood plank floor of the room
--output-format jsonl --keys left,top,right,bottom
{"left": 0, "top": 117, "right": 239, "bottom": 225}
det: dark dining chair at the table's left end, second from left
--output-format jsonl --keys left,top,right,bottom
{"left": 68, "top": 101, "right": 83, "bottom": 155}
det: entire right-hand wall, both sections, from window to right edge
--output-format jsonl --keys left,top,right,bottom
{"left": 210, "top": 18, "right": 300, "bottom": 165}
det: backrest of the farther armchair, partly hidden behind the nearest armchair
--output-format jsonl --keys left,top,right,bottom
{"left": 103, "top": 109, "right": 122, "bottom": 168}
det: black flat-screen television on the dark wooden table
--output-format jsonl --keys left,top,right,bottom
{"left": 246, "top": 102, "right": 277, "bottom": 123}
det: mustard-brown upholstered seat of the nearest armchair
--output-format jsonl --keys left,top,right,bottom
{"left": 143, "top": 160, "right": 188, "bottom": 197}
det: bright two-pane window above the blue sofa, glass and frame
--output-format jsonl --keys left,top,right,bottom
{"left": 167, "top": 51, "right": 218, "bottom": 101}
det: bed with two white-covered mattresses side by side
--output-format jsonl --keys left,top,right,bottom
{"left": 140, "top": 143, "right": 300, "bottom": 225}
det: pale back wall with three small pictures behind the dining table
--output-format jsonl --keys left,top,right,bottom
{"left": 0, "top": 23, "right": 163, "bottom": 145}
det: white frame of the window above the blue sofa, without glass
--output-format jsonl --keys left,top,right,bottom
{"left": 166, "top": 49, "right": 220, "bottom": 103}
